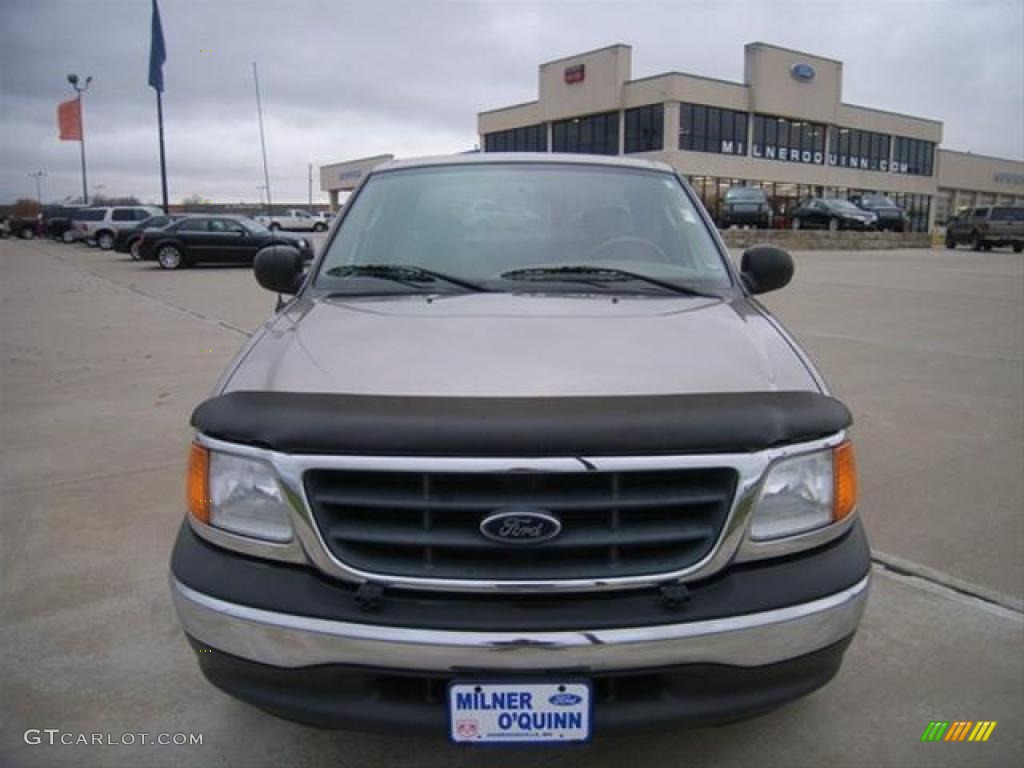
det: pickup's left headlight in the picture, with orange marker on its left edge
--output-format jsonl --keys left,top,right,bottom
{"left": 188, "top": 443, "right": 293, "bottom": 542}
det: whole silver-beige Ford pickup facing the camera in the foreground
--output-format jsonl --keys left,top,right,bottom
{"left": 171, "top": 154, "right": 870, "bottom": 744}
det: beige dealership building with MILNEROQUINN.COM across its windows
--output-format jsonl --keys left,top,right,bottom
{"left": 477, "top": 43, "right": 1024, "bottom": 231}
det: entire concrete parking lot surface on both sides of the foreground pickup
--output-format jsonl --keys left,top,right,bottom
{"left": 0, "top": 241, "right": 1024, "bottom": 767}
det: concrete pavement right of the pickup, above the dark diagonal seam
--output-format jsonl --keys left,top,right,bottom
{"left": 766, "top": 249, "right": 1024, "bottom": 600}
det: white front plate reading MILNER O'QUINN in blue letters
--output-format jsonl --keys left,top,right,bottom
{"left": 449, "top": 680, "right": 591, "bottom": 744}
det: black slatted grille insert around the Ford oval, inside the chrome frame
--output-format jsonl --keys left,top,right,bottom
{"left": 304, "top": 468, "right": 737, "bottom": 580}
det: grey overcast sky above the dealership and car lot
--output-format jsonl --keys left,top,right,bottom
{"left": 0, "top": 0, "right": 1024, "bottom": 203}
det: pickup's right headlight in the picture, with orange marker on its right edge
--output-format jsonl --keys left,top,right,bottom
{"left": 750, "top": 442, "right": 857, "bottom": 541}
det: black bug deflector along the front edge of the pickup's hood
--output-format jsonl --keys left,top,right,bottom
{"left": 191, "top": 391, "right": 852, "bottom": 458}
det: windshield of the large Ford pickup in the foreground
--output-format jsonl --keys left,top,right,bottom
{"left": 313, "top": 163, "right": 730, "bottom": 293}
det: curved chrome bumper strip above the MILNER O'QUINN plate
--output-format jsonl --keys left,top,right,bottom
{"left": 171, "top": 577, "right": 869, "bottom": 673}
